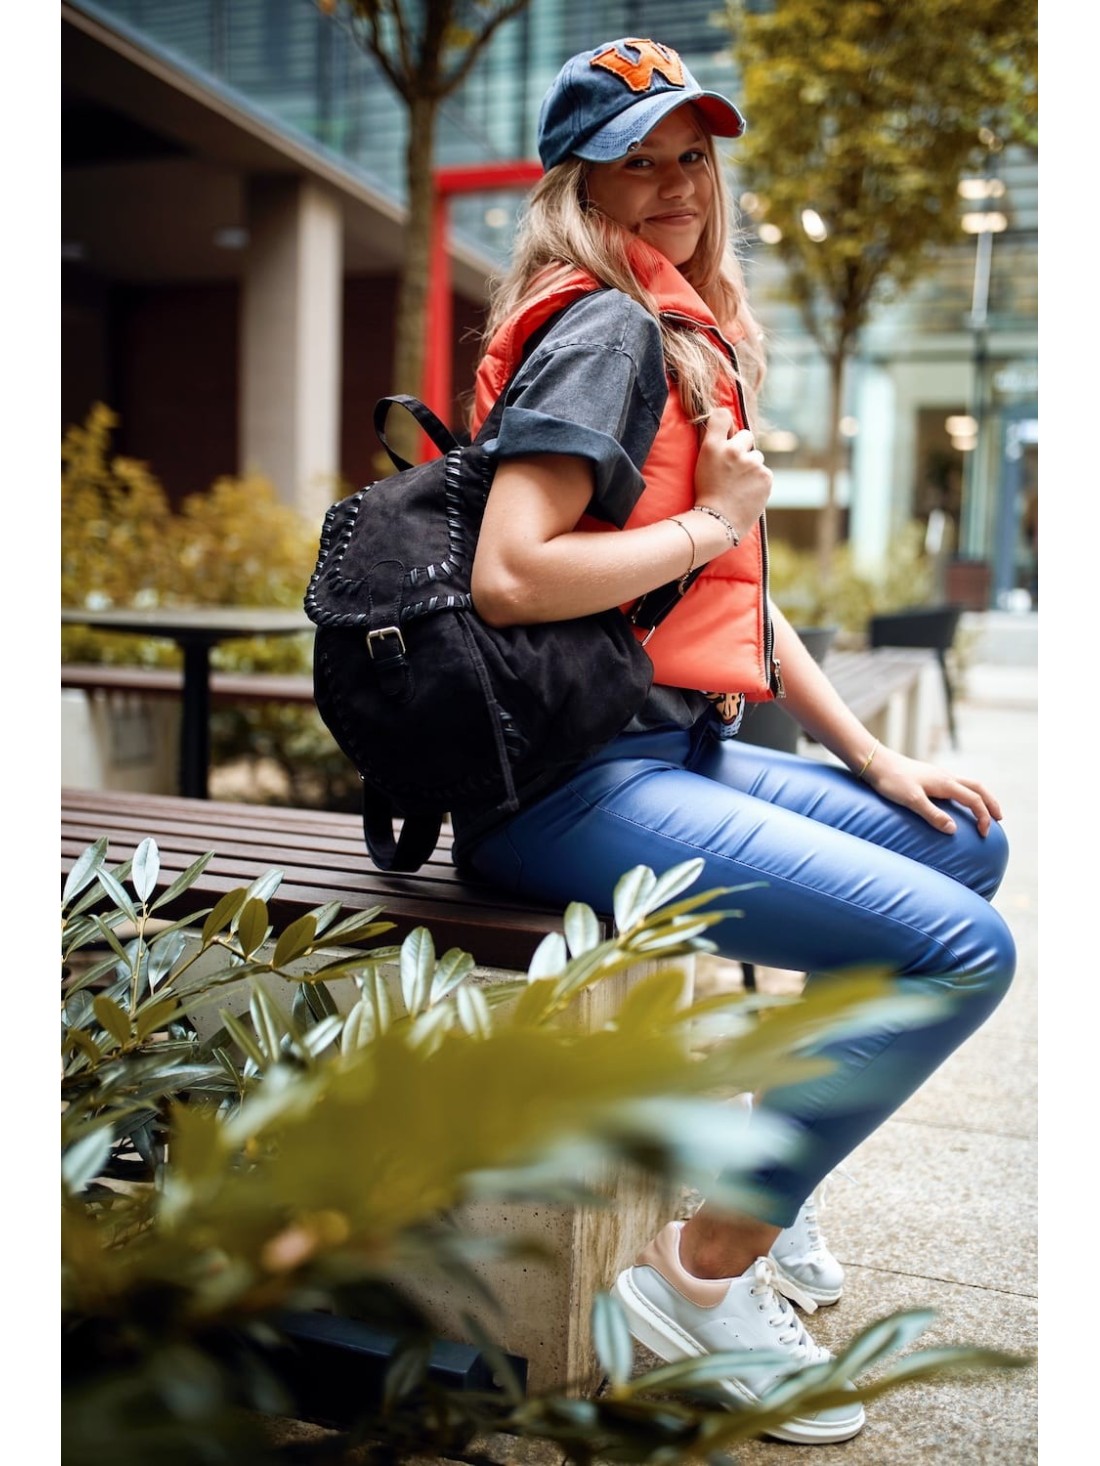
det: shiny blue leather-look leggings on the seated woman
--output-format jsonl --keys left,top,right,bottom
{"left": 471, "top": 726, "right": 1015, "bottom": 1227}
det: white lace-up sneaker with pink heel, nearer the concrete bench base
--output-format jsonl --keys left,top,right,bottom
{"left": 615, "top": 1221, "right": 864, "bottom": 1445}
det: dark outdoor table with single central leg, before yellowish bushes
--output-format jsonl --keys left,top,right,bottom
{"left": 62, "top": 605, "right": 314, "bottom": 799}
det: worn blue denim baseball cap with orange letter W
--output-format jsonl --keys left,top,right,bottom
{"left": 538, "top": 37, "right": 745, "bottom": 169}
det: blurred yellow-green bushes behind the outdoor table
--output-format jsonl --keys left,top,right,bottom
{"left": 62, "top": 403, "right": 359, "bottom": 809}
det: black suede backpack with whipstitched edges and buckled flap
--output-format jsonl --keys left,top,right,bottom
{"left": 305, "top": 378, "right": 698, "bottom": 871}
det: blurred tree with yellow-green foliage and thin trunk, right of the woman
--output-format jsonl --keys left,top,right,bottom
{"left": 727, "top": 0, "right": 1038, "bottom": 550}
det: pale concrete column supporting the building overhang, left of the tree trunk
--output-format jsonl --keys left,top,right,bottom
{"left": 241, "top": 179, "right": 343, "bottom": 522}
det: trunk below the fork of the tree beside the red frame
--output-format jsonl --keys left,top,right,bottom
{"left": 387, "top": 97, "right": 439, "bottom": 462}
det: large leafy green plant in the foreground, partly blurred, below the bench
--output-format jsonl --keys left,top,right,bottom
{"left": 62, "top": 839, "right": 1024, "bottom": 1466}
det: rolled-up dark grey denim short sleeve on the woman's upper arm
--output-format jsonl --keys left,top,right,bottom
{"left": 487, "top": 290, "right": 669, "bottom": 528}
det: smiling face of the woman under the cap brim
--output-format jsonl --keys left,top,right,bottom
{"left": 588, "top": 107, "right": 714, "bottom": 265}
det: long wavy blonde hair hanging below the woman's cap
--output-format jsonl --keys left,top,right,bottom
{"left": 483, "top": 120, "right": 764, "bottom": 421}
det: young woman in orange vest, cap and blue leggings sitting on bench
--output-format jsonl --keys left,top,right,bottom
{"left": 455, "top": 38, "right": 1015, "bottom": 1443}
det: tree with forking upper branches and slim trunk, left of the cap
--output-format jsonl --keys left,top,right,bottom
{"left": 317, "top": 0, "right": 529, "bottom": 460}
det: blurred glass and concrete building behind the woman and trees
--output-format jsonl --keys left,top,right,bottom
{"left": 62, "top": 0, "right": 1038, "bottom": 610}
